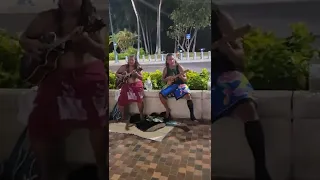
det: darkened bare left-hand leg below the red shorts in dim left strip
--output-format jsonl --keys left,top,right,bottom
{"left": 31, "top": 139, "right": 67, "bottom": 180}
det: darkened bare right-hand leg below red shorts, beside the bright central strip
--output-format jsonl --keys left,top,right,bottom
{"left": 90, "top": 127, "right": 109, "bottom": 180}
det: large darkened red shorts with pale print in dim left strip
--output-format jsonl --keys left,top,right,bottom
{"left": 29, "top": 61, "right": 108, "bottom": 139}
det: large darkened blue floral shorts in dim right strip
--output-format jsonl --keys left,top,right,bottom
{"left": 211, "top": 71, "right": 253, "bottom": 122}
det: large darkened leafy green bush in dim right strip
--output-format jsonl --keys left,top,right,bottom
{"left": 243, "top": 23, "right": 315, "bottom": 90}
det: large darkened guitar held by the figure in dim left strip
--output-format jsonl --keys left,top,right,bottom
{"left": 20, "top": 19, "right": 105, "bottom": 85}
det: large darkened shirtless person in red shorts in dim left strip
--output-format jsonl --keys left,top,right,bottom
{"left": 20, "top": 0, "right": 108, "bottom": 180}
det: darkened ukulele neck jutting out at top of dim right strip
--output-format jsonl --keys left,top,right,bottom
{"left": 211, "top": 24, "right": 252, "bottom": 50}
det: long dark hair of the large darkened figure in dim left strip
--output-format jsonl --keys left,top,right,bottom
{"left": 53, "top": 0, "right": 99, "bottom": 35}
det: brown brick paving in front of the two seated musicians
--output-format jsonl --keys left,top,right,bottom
{"left": 109, "top": 120, "right": 211, "bottom": 180}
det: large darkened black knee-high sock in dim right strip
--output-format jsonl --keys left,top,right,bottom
{"left": 245, "top": 121, "right": 271, "bottom": 180}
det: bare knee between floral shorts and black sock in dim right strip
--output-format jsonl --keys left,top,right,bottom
{"left": 232, "top": 101, "right": 259, "bottom": 122}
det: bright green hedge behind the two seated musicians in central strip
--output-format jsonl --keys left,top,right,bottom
{"left": 109, "top": 69, "right": 210, "bottom": 90}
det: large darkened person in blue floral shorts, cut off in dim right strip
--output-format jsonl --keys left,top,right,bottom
{"left": 211, "top": 5, "right": 271, "bottom": 180}
